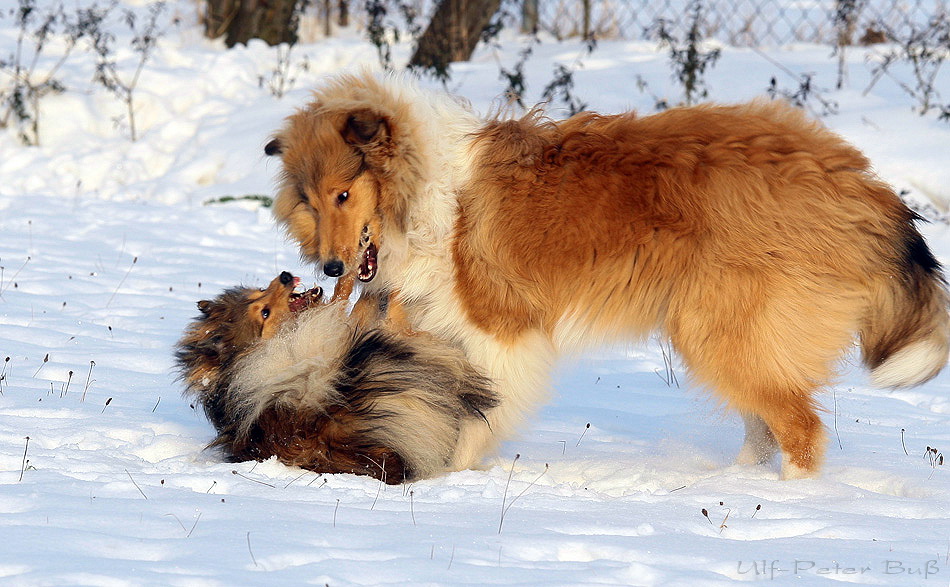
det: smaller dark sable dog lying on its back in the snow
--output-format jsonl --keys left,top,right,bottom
{"left": 177, "top": 271, "right": 495, "bottom": 483}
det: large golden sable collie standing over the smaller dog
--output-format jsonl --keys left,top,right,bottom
{"left": 265, "top": 74, "right": 950, "bottom": 478}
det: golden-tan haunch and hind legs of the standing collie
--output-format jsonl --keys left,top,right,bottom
{"left": 667, "top": 271, "right": 861, "bottom": 479}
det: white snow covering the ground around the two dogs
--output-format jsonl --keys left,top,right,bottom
{"left": 0, "top": 0, "right": 950, "bottom": 586}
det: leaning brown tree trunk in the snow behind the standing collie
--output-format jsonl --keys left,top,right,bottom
{"left": 409, "top": 0, "right": 501, "bottom": 76}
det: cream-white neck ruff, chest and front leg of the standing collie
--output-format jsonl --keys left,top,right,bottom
{"left": 358, "top": 78, "right": 555, "bottom": 470}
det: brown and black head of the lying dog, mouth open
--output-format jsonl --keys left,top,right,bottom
{"left": 176, "top": 271, "right": 323, "bottom": 400}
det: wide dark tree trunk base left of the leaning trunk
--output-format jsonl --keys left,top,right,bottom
{"left": 205, "top": 0, "right": 300, "bottom": 47}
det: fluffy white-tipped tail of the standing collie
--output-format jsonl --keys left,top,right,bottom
{"left": 861, "top": 220, "right": 950, "bottom": 387}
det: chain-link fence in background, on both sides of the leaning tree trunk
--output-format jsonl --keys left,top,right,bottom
{"left": 332, "top": 0, "right": 950, "bottom": 46}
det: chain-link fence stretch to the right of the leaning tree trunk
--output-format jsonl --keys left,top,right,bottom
{"left": 526, "top": 0, "right": 947, "bottom": 46}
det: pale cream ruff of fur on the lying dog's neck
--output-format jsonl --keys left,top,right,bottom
{"left": 230, "top": 304, "right": 352, "bottom": 433}
